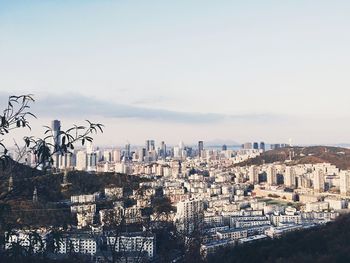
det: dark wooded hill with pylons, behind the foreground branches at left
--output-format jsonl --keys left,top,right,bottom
{"left": 0, "top": 161, "right": 146, "bottom": 230}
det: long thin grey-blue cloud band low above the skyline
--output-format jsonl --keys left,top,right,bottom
{"left": 0, "top": 94, "right": 280, "bottom": 123}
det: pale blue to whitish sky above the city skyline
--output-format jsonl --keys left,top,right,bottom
{"left": 0, "top": 0, "right": 350, "bottom": 145}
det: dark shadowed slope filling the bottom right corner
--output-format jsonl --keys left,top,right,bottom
{"left": 208, "top": 215, "right": 350, "bottom": 263}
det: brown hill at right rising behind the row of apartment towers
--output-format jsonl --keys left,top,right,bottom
{"left": 238, "top": 146, "right": 350, "bottom": 169}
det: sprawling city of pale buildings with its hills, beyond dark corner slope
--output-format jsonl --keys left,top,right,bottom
{"left": 0, "top": 120, "right": 350, "bottom": 262}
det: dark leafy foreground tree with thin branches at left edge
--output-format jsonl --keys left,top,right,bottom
{"left": 0, "top": 94, "right": 103, "bottom": 259}
